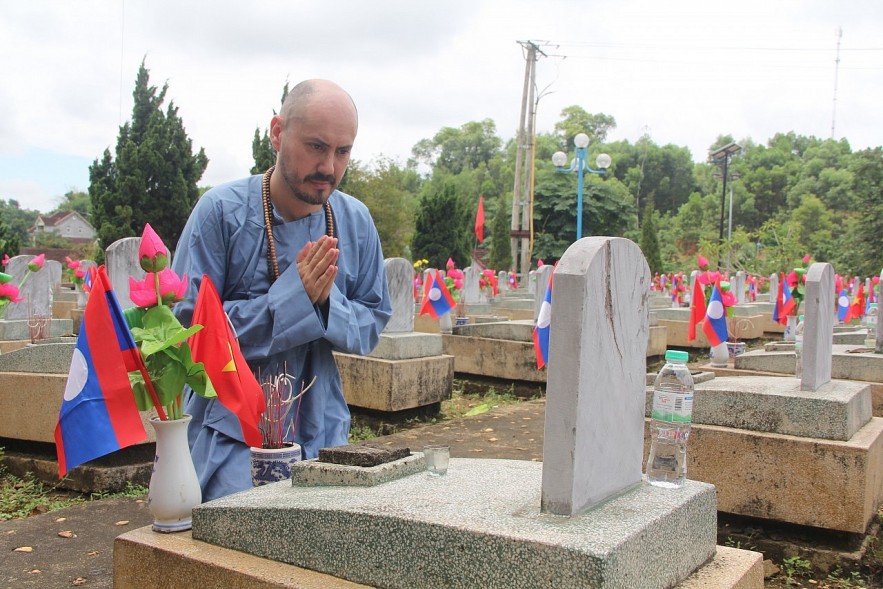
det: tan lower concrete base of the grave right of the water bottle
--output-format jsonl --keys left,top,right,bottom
{"left": 644, "top": 418, "right": 883, "bottom": 533}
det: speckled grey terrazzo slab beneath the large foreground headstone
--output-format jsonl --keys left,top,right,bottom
{"left": 190, "top": 458, "right": 717, "bottom": 589}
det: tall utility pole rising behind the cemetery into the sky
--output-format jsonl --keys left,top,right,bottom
{"left": 510, "top": 41, "right": 546, "bottom": 280}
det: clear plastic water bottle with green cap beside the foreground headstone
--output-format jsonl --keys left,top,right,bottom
{"left": 647, "top": 350, "right": 693, "bottom": 489}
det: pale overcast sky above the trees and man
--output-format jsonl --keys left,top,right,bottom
{"left": 0, "top": 0, "right": 883, "bottom": 212}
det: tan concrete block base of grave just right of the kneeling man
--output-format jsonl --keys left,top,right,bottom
{"left": 334, "top": 352, "right": 454, "bottom": 412}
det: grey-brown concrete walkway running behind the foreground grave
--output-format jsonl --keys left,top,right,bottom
{"left": 0, "top": 399, "right": 545, "bottom": 589}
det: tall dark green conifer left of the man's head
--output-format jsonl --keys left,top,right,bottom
{"left": 89, "top": 62, "right": 208, "bottom": 259}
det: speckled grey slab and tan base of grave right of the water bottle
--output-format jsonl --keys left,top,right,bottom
{"left": 644, "top": 376, "right": 883, "bottom": 533}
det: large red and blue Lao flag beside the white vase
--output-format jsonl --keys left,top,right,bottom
{"left": 55, "top": 266, "right": 147, "bottom": 478}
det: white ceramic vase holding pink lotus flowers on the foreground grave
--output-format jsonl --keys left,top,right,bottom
{"left": 147, "top": 415, "right": 202, "bottom": 532}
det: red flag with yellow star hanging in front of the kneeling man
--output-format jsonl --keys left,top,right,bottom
{"left": 188, "top": 274, "right": 266, "bottom": 448}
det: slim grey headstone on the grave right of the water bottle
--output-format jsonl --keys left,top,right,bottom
{"left": 800, "top": 262, "right": 835, "bottom": 391}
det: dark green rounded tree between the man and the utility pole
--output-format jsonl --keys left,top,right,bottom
{"left": 411, "top": 182, "right": 474, "bottom": 268}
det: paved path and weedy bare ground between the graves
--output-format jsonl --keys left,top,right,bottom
{"left": 0, "top": 374, "right": 883, "bottom": 589}
